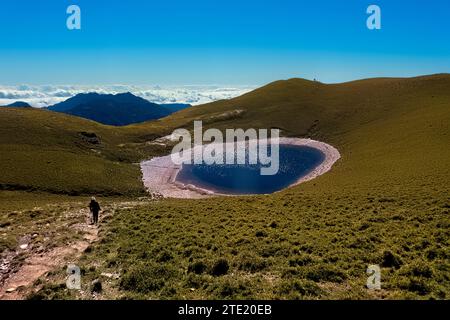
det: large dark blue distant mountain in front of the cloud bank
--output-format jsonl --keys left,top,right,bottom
{"left": 46, "top": 92, "right": 190, "bottom": 126}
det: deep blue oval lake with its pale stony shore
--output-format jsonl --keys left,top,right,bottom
{"left": 141, "top": 138, "right": 340, "bottom": 198}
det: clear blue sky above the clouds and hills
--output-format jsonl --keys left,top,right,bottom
{"left": 0, "top": 0, "right": 450, "bottom": 85}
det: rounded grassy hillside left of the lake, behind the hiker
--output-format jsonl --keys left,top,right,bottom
{"left": 0, "top": 108, "right": 148, "bottom": 194}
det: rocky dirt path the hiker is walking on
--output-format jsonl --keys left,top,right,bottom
{"left": 0, "top": 203, "right": 121, "bottom": 300}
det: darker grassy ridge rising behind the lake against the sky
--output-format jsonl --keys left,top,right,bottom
{"left": 146, "top": 74, "right": 450, "bottom": 139}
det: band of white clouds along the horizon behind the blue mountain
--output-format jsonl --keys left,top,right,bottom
{"left": 0, "top": 85, "right": 256, "bottom": 108}
